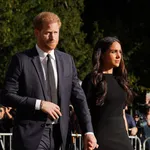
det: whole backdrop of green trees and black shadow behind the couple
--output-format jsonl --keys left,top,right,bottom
{"left": 0, "top": 0, "right": 150, "bottom": 93}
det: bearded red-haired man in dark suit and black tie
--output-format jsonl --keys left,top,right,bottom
{"left": 4, "top": 12, "right": 97, "bottom": 150}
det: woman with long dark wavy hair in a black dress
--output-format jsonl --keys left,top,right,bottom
{"left": 82, "top": 37, "right": 134, "bottom": 150}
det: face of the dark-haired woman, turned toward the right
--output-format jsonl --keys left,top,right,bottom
{"left": 102, "top": 42, "right": 122, "bottom": 69}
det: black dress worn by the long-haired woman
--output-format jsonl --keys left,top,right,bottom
{"left": 82, "top": 74, "right": 133, "bottom": 150}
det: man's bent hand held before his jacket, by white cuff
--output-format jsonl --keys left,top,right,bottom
{"left": 41, "top": 101, "right": 62, "bottom": 120}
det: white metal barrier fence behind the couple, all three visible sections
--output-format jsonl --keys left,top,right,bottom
{"left": 0, "top": 133, "right": 150, "bottom": 150}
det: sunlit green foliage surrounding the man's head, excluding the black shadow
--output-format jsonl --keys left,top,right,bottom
{"left": 0, "top": 0, "right": 91, "bottom": 86}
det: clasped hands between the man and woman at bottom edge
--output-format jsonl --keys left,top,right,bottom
{"left": 84, "top": 134, "right": 99, "bottom": 150}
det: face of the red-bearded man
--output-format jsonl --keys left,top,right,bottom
{"left": 35, "top": 22, "right": 59, "bottom": 52}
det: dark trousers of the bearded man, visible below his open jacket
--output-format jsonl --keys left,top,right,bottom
{"left": 37, "top": 124, "right": 62, "bottom": 150}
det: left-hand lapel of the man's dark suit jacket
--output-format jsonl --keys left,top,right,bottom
{"left": 32, "top": 48, "right": 47, "bottom": 99}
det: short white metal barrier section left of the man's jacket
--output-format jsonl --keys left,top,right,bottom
{"left": 0, "top": 133, "right": 12, "bottom": 150}
